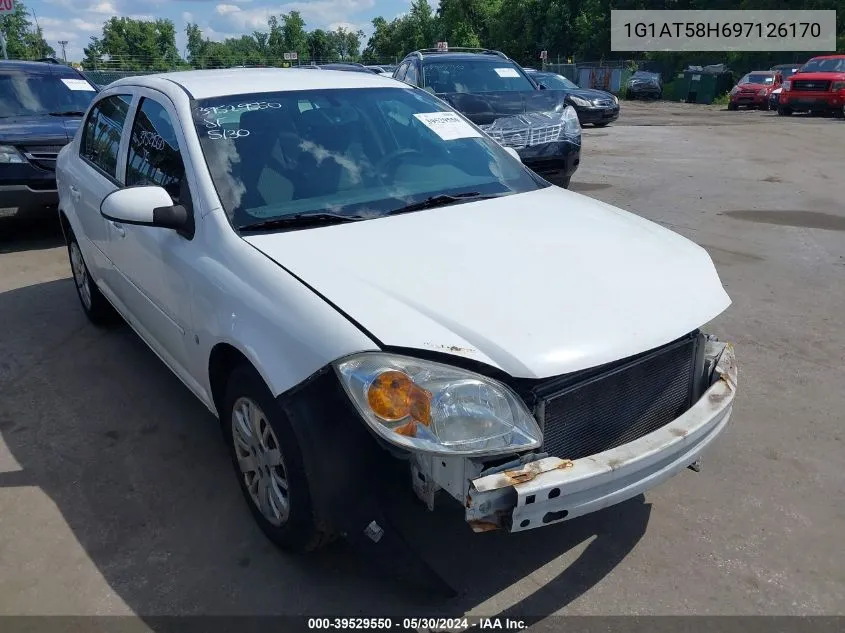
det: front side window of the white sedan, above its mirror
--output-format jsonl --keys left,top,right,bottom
{"left": 126, "top": 98, "right": 185, "bottom": 201}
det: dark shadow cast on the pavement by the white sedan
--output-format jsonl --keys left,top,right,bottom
{"left": 0, "top": 279, "right": 651, "bottom": 630}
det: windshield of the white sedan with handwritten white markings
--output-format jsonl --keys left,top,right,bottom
{"left": 194, "top": 88, "right": 546, "bottom": 230}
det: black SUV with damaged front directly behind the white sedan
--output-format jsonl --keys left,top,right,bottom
{"left": 393, "top": 49, "right": 581, "bottom": 187}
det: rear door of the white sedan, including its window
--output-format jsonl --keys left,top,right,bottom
{"left": 71, "top": 90, "right": 132, "bottom": 294}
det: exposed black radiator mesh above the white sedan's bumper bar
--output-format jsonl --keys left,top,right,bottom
{"left": 543, "top": 337, "right": 696, "bottom": 459}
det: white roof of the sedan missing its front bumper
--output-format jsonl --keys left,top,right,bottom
{"left": 109, "top": 68, "right": 409, "bottom": 99}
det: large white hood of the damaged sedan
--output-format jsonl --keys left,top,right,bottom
{"left": 244, "top": 187, "right": 730, "bottom": 378}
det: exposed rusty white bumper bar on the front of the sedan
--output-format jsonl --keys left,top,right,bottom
{"left": 412, "top": 341, "right": 737, "bottom": 532}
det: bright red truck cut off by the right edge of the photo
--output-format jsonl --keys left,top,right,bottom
{"left": 778, "top": 55, "right": 845, "bottom": 117}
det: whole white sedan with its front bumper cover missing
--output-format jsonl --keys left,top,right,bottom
{"left": 57, "top": 69, "right": 736, "bottom": 550}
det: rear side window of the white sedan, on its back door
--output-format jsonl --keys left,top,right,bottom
{"left": 79, "top": 95, "right": 132, "bottom": 179}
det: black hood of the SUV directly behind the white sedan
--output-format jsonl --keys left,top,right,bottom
{"left": 437, "top": 90, "right": 567, "bottom": 125}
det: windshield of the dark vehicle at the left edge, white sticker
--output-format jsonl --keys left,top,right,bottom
{"left": 0, "top": 72, "right": 96, "bottom": 117}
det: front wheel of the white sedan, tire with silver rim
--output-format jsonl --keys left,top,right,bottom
{"left": 220, "top": 364, "right": 332, "bottom": 553}
